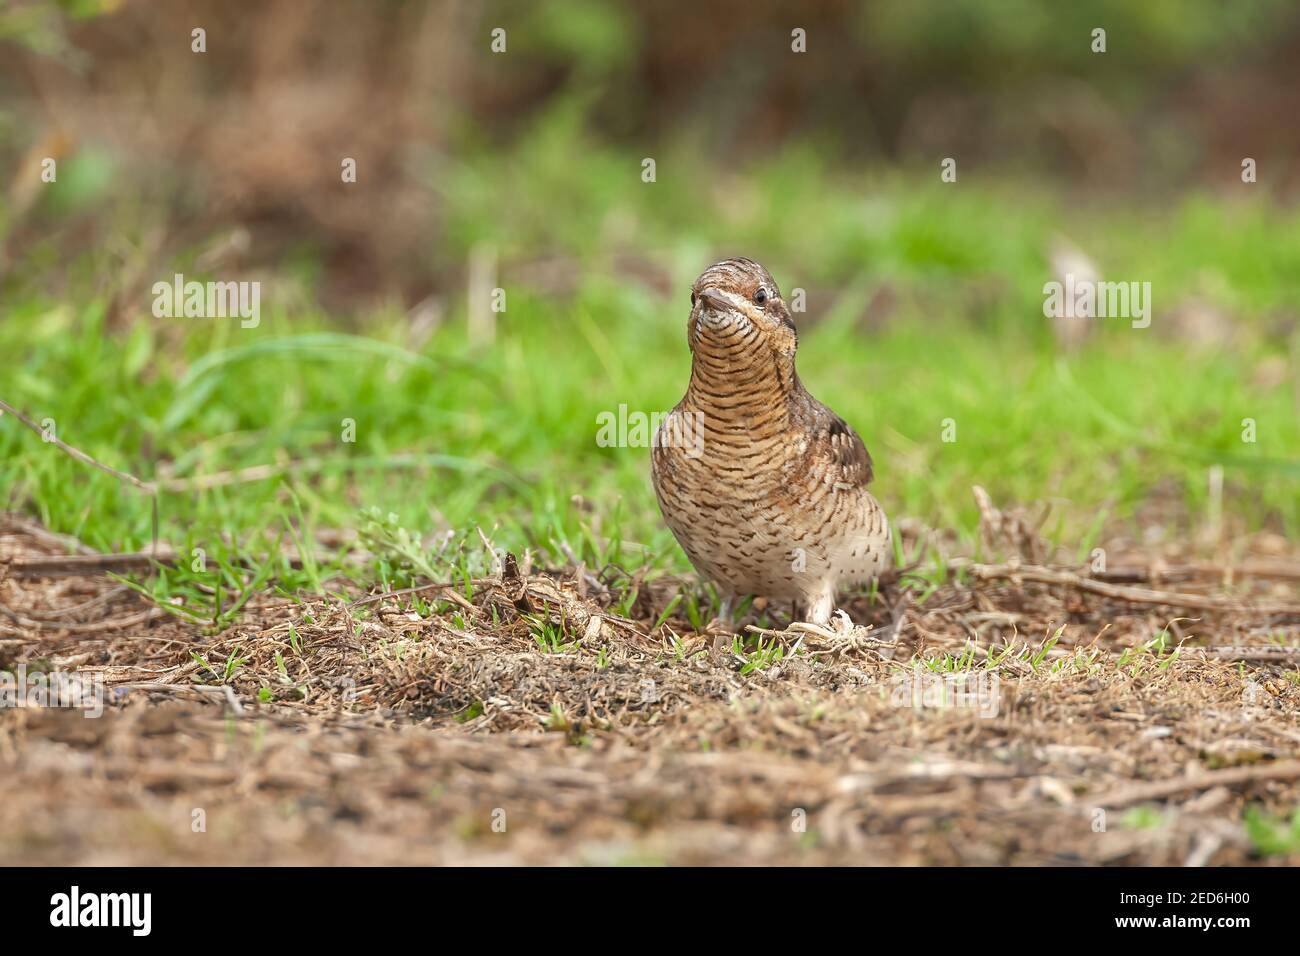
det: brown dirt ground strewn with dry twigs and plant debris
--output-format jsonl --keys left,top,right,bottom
{"left": 0, "top": 512, "right": 1300, "bottom": 865}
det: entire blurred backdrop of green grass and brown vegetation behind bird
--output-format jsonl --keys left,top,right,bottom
{"left": 0, "top": 0, "right": 1300, "bottom": 587}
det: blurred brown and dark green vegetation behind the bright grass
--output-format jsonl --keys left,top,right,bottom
{"left": 0, "top": 0, "right": 1300, "bottom": 299}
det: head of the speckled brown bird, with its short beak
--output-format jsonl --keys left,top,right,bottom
{"left": 688, "top": 259, "right": 798, "bottom": 363}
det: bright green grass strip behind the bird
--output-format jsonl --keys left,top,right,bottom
{"left": 0, "top": 138, "right": 1300, "bottom": 600}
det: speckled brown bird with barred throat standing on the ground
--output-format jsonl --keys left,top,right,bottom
{"left": 651, "top": 259, "right": 892, "bottom": 626}
